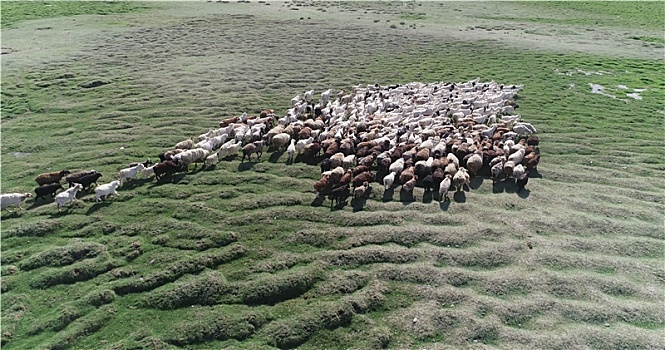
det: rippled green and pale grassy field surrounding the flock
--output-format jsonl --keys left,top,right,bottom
{"left": 0, "top": 1, "right": 665, "bottom": 349}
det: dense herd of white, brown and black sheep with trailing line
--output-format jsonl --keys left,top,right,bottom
{"left": 0, "top": 79, "right": 540, "bottom": 210}
